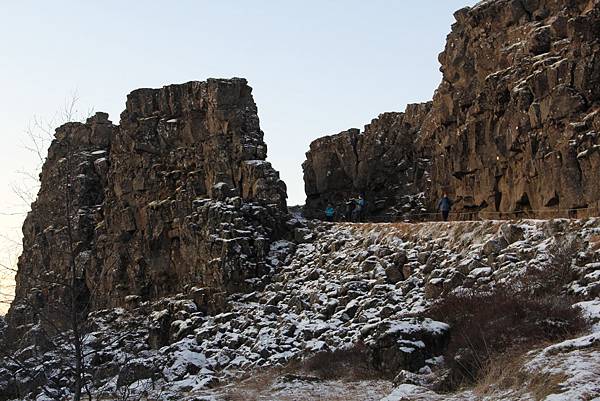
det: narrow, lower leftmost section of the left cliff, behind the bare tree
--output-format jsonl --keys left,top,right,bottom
{"left": 7, "top": 113, "right": 116, "bottom": 329}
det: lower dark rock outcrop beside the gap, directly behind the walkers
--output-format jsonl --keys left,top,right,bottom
{"left": 302, "top": 103, "right": 431, "bottom": 220}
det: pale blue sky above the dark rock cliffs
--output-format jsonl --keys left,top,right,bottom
{"left": 0, "top": 0, "right": 475, "bottom": 304}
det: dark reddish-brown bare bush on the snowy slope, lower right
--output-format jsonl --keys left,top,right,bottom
{"left": 430, "top": 239, "right": 586, "bottom": 390}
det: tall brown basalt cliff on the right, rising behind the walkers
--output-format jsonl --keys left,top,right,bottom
{"left": 304, "top": 0, "right": 600, "bottom": 217}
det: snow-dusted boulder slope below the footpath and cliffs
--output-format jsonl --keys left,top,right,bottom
{"left": 0, "top": 219, "right": 600, "bottom": 400}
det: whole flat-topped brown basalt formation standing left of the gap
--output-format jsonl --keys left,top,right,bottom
{"left": 8, "top": 78, "right": 290, "bottom": 329}
